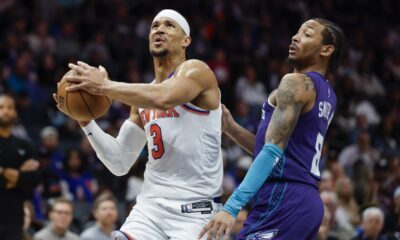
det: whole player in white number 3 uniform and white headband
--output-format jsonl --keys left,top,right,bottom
{"left": 55, "top": 10, "right": 223, "bottom": 240}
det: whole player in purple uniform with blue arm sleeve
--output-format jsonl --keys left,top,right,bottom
{"left": 200, "top": 18, "right": 344, "bottom": 240}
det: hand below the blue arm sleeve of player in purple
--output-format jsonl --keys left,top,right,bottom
{"left": 198, "top": 211, "right": 236, "bottom": 240}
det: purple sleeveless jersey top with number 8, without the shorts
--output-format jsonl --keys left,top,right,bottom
{"left": 254, "top": 72, "right": 336, "bottom": 187}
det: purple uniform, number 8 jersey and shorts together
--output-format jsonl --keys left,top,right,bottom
{"left": 238, "top": 72, "right": 336, "bottom": 240}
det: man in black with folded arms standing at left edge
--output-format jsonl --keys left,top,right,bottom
{"left": 0, "top": 94, "right": 40, "bottom": 240}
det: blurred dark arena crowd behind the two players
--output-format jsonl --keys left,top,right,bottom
{"left": 0, "top": 0, "right": 400, "bottom": 240}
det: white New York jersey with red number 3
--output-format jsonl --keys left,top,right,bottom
{"left": 139, "top": 103, "right": 223, "bottom": 201}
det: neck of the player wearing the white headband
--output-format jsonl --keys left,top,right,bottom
{"left": 154, "top": 55, "right": 186, "bottom": 82}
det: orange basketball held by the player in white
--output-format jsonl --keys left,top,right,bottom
{"left": 57, "top": 70, "right": 111, "bottom": 121}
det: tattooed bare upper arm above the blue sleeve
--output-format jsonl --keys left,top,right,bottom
{"left": 265, "top": 73, "right": 315, "bottom": 149}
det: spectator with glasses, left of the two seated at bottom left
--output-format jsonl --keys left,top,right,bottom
{"left": 33, "top": 198, "right": 78, "bottom": 240}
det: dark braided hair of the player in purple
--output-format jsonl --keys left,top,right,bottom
{"left": 312, "top": 18, "right": 346, "bottom": 72}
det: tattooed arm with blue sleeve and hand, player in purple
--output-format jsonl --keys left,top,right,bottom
{"left": 200, "top": 73, "right": 315, "bottom": 239}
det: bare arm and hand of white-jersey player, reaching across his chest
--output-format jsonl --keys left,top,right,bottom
{"left": 66, "top": 60, "right": 219, "bottom": 110}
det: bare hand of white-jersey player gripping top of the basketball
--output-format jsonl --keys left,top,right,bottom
{"left": 65, "top": 61, "right": 109, "bottom": 95}
